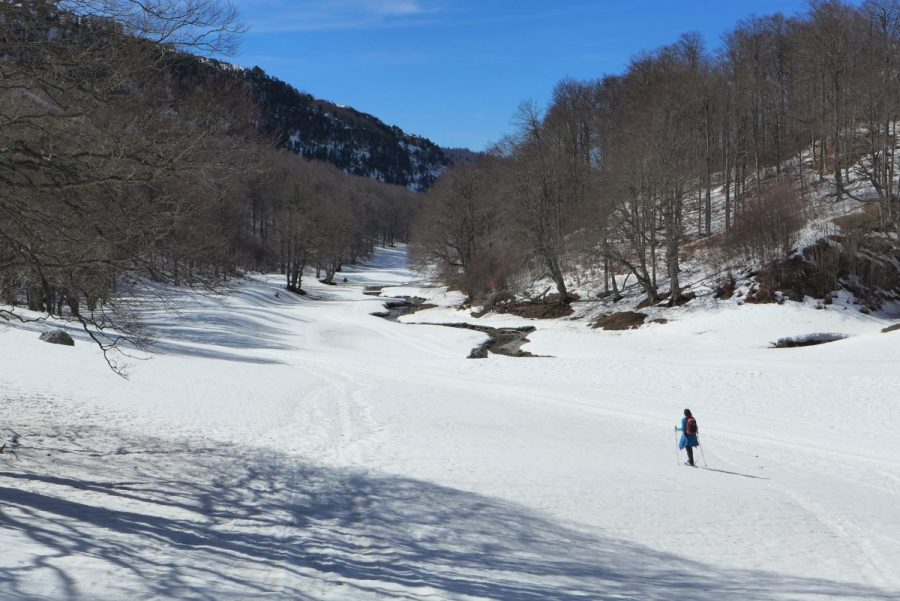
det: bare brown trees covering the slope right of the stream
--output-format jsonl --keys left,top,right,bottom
{"left": 414, "top": 0, "right": 900, "bottom": 303}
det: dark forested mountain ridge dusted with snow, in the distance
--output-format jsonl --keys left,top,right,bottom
{"left": 239, "top": 67, "right": 452, "bottom": 191}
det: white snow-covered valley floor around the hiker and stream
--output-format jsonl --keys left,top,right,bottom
{"left": 0, "top": 249, "right": 900, "bottom": 601}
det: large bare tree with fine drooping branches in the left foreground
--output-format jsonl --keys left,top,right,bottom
{"left": 0, "top": 0, "right": 252, "bottom": 368}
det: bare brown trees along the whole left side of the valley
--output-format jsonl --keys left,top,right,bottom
{"left": 0, "top": 0, "right": 416, "bottom": 364}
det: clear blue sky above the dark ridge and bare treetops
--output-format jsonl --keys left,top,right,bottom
{"left": 230, "top": 0, "right": 828, "bottom": 150}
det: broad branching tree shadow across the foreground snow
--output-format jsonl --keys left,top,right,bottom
{"left": 0, "top": 426, "right": 900, "bottom": 601}
